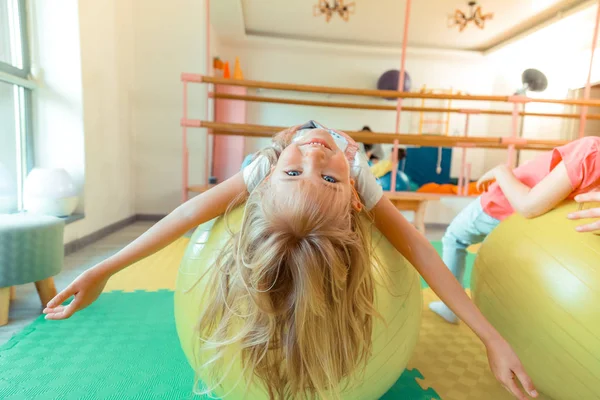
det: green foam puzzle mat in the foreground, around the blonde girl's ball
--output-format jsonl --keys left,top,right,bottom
{"left": 0, "top": 290, "right": 439, "bottom": 400}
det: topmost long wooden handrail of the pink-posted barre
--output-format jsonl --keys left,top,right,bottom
{"left": 195, "top": 74, "right": 600, "bottom": 107}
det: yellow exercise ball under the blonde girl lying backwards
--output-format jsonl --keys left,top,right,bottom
{"left": 175, "top": 208, "right": 423, "bottom": 400}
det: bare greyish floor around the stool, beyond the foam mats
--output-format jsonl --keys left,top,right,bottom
{"left": 0, "top": 222, "right": 444, "bottom": 345}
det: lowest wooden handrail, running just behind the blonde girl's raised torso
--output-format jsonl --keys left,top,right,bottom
{"left": 181, "top": 120, "right": 568, "bottom": 150}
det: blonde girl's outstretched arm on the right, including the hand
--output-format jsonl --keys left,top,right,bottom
{"left": 372, "top": 196, "right": 537, "bottom": 399}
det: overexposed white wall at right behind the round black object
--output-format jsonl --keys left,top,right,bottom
{"left": 488, "top": 6, "right": 600, "bottom": 166}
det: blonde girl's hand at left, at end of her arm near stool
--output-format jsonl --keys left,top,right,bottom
{"left": 44, "top": 268, "right": 111, "bottom": 320}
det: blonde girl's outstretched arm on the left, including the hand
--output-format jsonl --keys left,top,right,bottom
{"left": 44, "top": 172, "right": 246, "bottom": 319}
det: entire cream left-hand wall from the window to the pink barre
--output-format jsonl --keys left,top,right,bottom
{"left": 31, "top": 0, "right": 223, "bottom": 238}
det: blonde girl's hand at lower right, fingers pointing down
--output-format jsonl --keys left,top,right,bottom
{"left": 486, "top": 338, "right": 538, "bottom": 400}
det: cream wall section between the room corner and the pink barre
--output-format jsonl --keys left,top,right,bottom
{"left": 132, "top": 0, "right": 218, "bottom": 214}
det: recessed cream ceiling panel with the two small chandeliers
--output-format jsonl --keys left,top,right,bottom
{"left": 211, "top": 0, "right": 594, "bottom": 51}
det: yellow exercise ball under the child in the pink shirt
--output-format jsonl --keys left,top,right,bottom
{"left": 471, "top": 202, "right": 600, "bottom": 400}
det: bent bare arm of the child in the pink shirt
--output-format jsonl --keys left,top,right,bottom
{"left": 482, "top": 161, "right": 573, "bottom": 218}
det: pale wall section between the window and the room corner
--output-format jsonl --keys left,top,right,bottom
{"left": 30, "top": 0, "right": 134, "bottom": 242}
